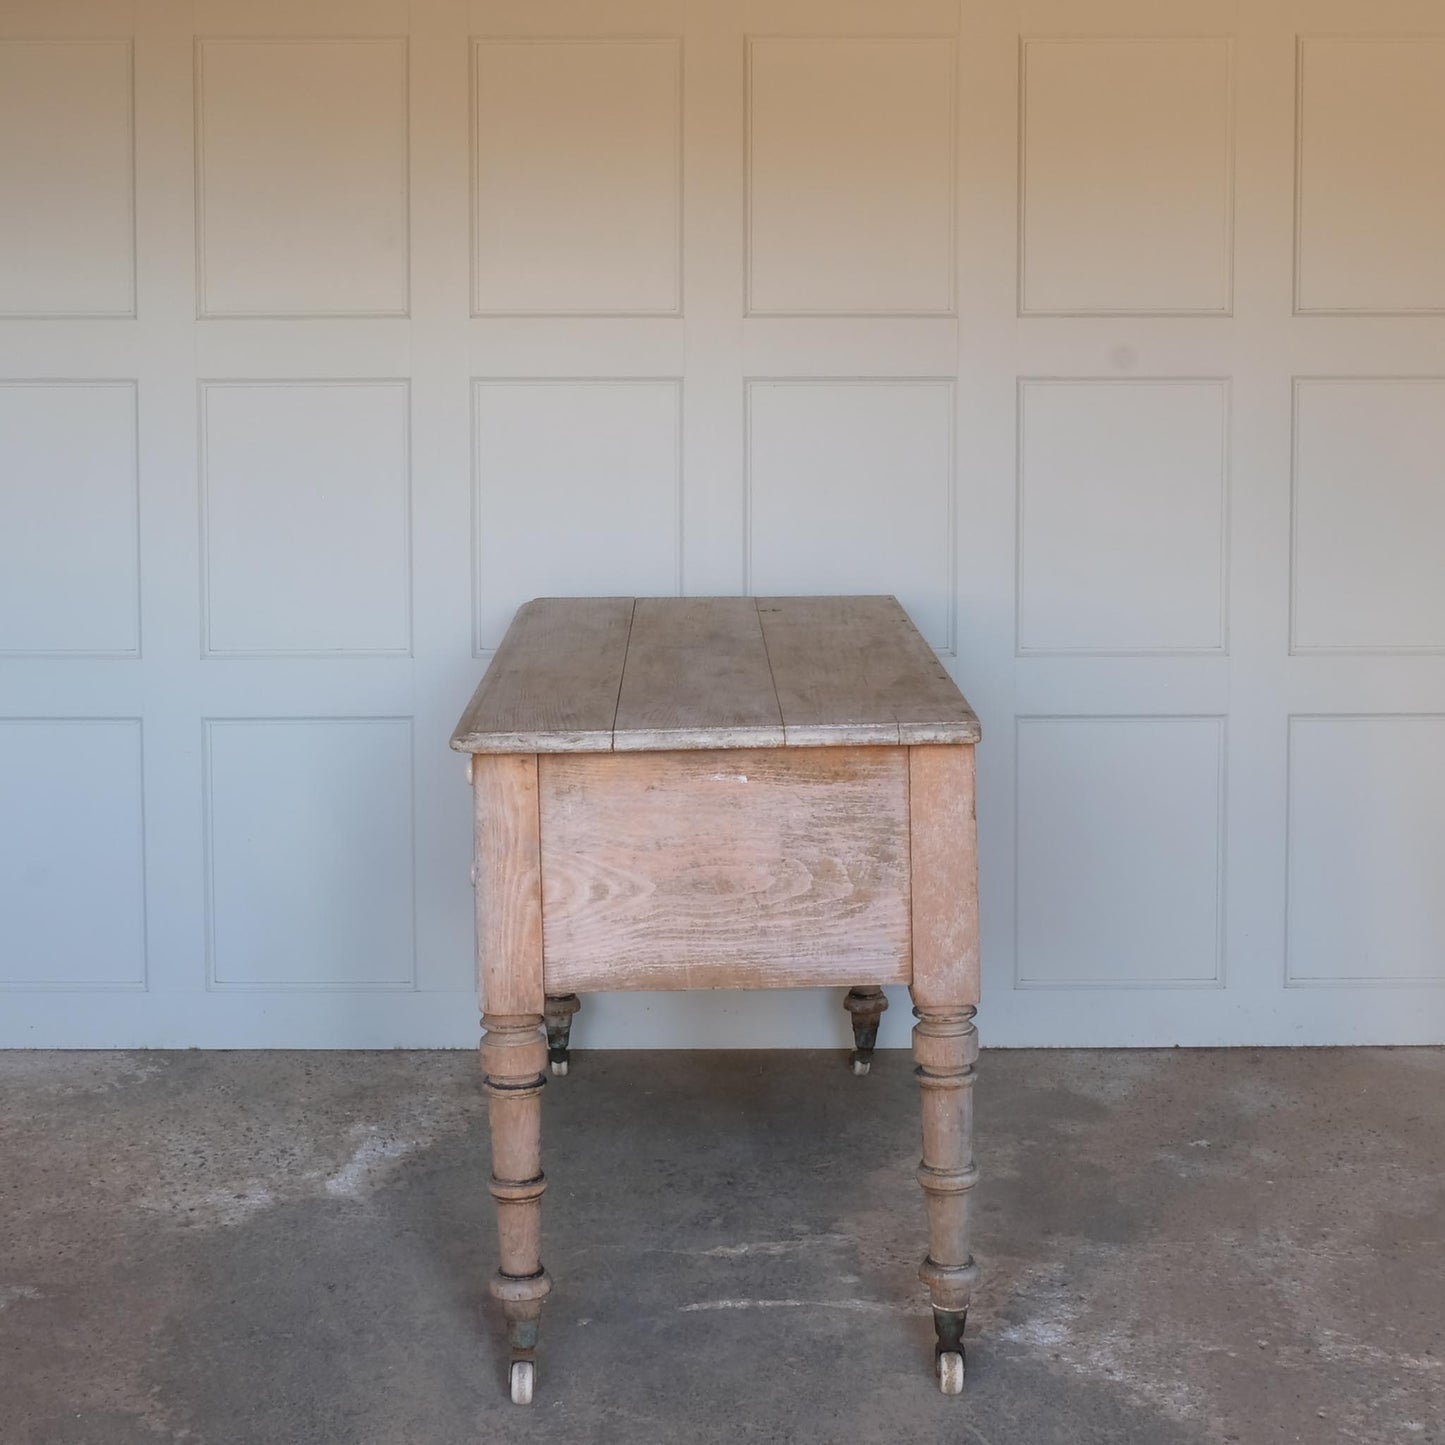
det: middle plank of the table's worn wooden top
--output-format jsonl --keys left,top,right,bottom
{"left": 613, "top": 597, "right": 783, "bottom": 751}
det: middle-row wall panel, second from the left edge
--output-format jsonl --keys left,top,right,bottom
{"left": 201, "top": 381, "right": 410, "bottom": 653}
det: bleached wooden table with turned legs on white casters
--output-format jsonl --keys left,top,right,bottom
{"left": 451, "top": 597, "right": 980, "bottom": 1403}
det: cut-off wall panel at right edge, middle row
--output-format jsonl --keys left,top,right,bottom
{"left": 1293, "top": 379, "right": 1445, "bottom": 652}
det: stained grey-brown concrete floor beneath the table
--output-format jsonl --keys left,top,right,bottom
{"left": 0, "top": 1049, "right": 1445, "bottom": 1445}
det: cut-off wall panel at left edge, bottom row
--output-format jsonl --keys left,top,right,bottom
{"left": 0, "top": 718, "right": 146, "bottom": 990}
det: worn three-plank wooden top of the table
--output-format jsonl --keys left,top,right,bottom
{"left": 451, "top": 597, "right": 980, "bottom": 753}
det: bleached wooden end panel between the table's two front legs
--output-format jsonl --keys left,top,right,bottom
{"left": 539, "top": 747, "right": 909, "bottom": 993}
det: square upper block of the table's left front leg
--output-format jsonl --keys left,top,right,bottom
{"left": 473, "top": 753, "right": 543, "bottom": 1017}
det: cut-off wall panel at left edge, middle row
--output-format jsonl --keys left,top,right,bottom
{"left": 0, "top": 381, "right": 140, "bottom": 655}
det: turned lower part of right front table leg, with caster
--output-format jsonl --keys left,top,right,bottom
{"left": 913, "top": 1007, "right": 978, "bottom": 1394}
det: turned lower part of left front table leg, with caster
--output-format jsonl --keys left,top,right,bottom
{"left": 481, "top": 1013, "right": 552, "bottom": 1405}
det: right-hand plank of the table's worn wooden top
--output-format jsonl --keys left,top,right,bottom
{"left": 756, "top": 597, "right": 980, "bottom": 747}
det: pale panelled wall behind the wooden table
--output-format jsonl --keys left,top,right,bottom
{"left": 0, "top": 0, "right": 1445, "bottom": 1046}
